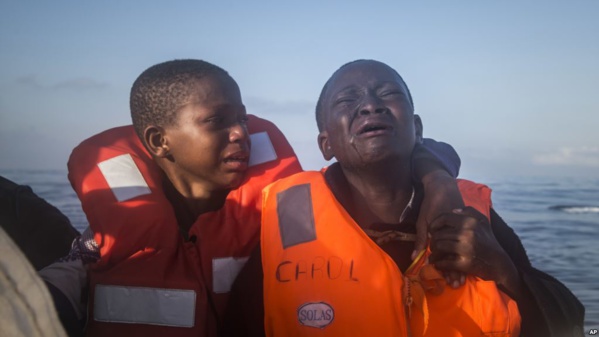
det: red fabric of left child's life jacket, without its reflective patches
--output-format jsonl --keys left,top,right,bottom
{"left": 68, "top": 115, "right": 301, "bottom": 337}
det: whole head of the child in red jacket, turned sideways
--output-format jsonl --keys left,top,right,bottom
{"left": 130, "top": 60, "right": 250, "bottom": 195}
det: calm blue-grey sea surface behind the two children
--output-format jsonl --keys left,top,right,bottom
{"left": 0, "top": 170, "right": 599, "bottom": 332}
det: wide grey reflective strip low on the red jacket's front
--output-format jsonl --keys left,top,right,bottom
{"left": 94, "top": 284, "right": 196, "bottom": 328}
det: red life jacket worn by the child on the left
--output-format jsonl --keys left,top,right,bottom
{"left": 68, "top": 115, "right": 301, "bottom": 337}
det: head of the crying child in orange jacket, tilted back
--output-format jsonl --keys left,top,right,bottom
{"left": 316, "top": 60, "right": 422, "bottom": 177}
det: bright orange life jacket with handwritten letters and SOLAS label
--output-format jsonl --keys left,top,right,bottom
{"left": 261, "top": 172, "right": 521, "bottom": 337}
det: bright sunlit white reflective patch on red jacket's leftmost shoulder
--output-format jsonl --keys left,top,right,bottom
{"left": 98, "top": 153, "right": 151, "bottom": 202}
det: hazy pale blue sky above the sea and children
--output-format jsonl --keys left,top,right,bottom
{"left": 0, "top": 0, "right": 599, "bottom": 177}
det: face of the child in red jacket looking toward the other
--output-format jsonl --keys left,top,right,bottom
{"left": 165, "top": 76, "right": 250, "bottom": 190}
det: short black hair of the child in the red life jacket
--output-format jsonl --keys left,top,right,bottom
{"left": 129, "top": 59, "right": 232, "bottom": 140}
